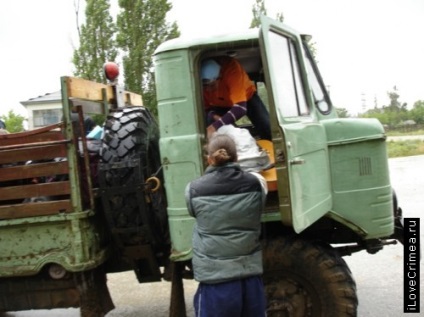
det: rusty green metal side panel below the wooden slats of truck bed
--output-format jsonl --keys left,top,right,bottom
{"left": 0, "top": 212, "right": 107, "bottom": 277}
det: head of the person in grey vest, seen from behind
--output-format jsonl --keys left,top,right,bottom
{"left": 206, "top": 134, "right": 237, "bottom": 166}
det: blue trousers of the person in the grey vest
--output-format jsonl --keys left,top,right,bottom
{"left": 194, "top": 276, "right": 266, "bottom": 317}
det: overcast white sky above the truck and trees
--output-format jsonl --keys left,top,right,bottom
{"left": 0, "top": 0, "right": 424, "bottom": 116}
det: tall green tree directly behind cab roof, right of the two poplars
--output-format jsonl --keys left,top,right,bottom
{"left": 117, "top": 0, "right": 180, "bottom": 114}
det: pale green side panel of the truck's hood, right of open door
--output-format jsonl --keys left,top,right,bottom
{"left": 323, "top": 119, "right": 394, "bottom": 239}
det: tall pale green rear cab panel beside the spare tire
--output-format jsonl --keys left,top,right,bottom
{"left": 155, "top": 49, "right": 204, "bottom": 260}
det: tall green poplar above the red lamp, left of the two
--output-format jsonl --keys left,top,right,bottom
{"left": 73, "top": 0, "right": 118, "bottom": 82}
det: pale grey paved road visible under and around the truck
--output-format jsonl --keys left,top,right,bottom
{"left": 0, "top": 155, "right": 424, "bottom": 317}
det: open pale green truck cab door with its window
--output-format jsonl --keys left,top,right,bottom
{"left": 260, "top": 17, "right": 332, "bottom": 233}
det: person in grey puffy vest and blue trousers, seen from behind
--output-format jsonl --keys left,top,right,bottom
{"left": 185, "top": 134, "right": 267, "bottom": 317}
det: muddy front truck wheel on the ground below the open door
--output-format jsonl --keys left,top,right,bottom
{"left": 263, "top": 238, "right": 358, "bottom": 317}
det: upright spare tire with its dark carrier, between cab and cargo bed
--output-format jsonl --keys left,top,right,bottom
{"left": 99, "top": 107, "right": 171, "bottom": 283}
